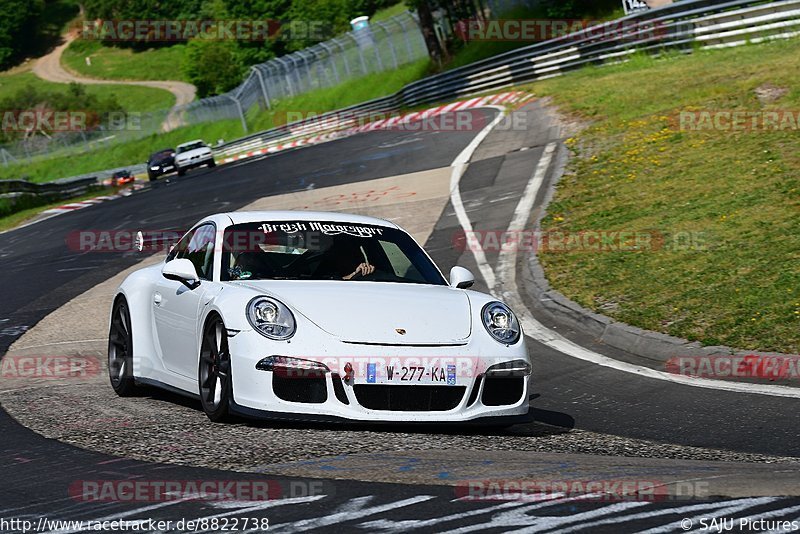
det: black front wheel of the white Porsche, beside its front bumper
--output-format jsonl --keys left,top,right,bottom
{"left": 197, "top": 315, "right": 233, "bottom": 423}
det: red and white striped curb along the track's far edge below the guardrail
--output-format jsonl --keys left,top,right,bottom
{"left": 220, "top": 91, "right": 533, "bottom": 164}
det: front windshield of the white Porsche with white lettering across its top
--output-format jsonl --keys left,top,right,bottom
{"left": 222, "top": 221, "right": 446, "bottom": 285}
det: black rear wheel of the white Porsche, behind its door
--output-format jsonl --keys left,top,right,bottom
{"left": 108, "top": 297, "right": 137, "bottom": 397}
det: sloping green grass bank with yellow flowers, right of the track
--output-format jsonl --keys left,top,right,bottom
{"left": 530, "top": 39, "right": 800, "bottom": 354}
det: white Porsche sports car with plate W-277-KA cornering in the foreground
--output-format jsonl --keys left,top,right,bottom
{"left": 108, "top": 211, "right": 531, "bottom": 424}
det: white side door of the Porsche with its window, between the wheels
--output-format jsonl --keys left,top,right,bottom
{"left": 152, "top": 223, "right": 216, "bottom": 378}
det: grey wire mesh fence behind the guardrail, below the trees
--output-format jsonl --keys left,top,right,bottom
{"left": 0, "top": 11, "right": 428, "bottom": 170}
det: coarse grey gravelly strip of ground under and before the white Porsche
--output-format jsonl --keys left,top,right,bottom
{"left": 0, "top": 378, "right": 800, "bottom": 471}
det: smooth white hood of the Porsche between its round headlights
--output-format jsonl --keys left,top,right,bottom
{"left": 237, "top": 280, "right": 472, "bottom": 345}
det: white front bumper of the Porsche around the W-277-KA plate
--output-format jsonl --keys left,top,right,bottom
{"left": 228, "top": 330, "right": 532, "bottom": 424}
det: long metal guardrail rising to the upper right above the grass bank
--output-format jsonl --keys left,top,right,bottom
{"left": 45, "top": 0, "right": 800, "bottom": 186}
